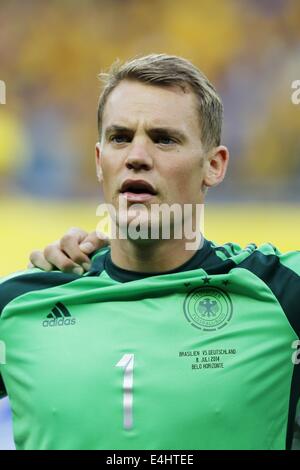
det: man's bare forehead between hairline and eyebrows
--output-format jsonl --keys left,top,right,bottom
{"left": 103, "top": 80, "right": 199, "bottom": 133}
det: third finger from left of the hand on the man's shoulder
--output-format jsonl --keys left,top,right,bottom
{"left": 59, "top": 229, "right": 90, "bottom": 271}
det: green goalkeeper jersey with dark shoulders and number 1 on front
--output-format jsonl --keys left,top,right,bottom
{"left": 0, "top": 240, "right": 300, "bottom": 450}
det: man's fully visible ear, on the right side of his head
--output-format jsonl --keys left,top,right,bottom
{"left": 203, "top": 145, "right": 229, "bottom": 188}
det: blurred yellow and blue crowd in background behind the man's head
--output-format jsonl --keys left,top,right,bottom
{"left": 0, "top": 0, "right": 300, "bottom": 201}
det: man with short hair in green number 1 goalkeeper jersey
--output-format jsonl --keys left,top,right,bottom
{"left": 0, "top": 55, "right": 300, "bottom": 449}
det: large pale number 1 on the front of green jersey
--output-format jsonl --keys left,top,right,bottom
{"left": 116, "top": 354, "right": 134, "bottom": 429}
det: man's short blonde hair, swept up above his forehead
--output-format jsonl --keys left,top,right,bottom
{"left": 98, "top": 54, "right": 223, "bottom": 150}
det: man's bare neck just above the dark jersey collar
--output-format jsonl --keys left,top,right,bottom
{"left": 111, "top": 233, "right": 203, "bottom": 273}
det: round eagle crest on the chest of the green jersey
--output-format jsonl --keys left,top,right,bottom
{"left": 183, "top": 287, "right": 232, "bottom": 331}
